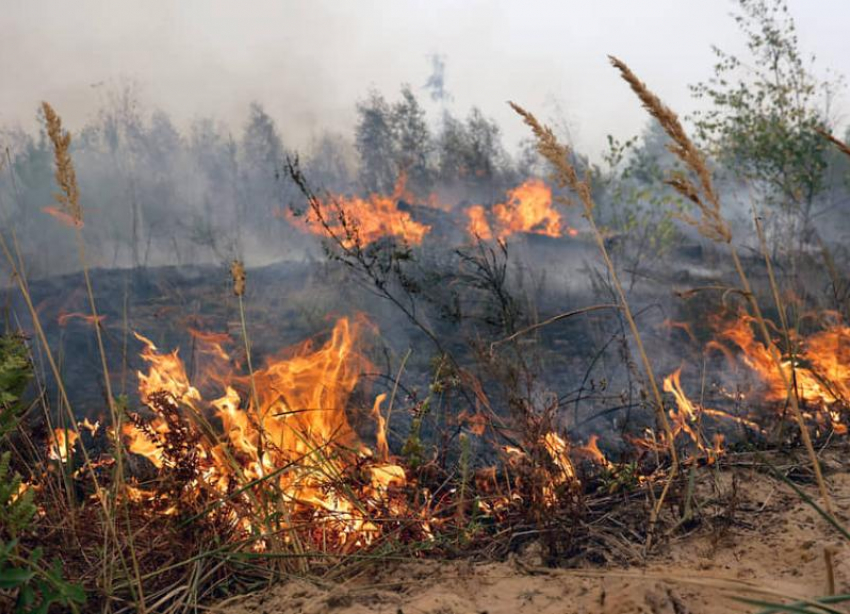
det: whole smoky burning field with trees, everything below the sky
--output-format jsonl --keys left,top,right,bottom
{"left": 0, "top": 0, "right": 850, "bottom": 614}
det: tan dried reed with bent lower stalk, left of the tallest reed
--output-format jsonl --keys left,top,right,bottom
{"left": 509, "top": 102, "right": 679, "bottom": 548}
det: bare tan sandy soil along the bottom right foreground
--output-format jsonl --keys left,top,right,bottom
{"left": 213, "top": 454, "right": 850, "bottom": 614}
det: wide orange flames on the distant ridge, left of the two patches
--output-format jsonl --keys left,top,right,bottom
{"left": 288, "top": 174, "right": 431, "bottom": 248}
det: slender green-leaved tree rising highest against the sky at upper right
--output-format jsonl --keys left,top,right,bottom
{"left": 691, "top": 0, "right": 834, "bottom": 246}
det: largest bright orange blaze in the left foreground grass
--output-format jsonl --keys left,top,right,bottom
{"left": 124, "top": 318, "right": 407, "bottom": 550}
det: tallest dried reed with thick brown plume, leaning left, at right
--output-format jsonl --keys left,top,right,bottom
{"left": 608, "top": 56, "right": 843, "bottom": 515}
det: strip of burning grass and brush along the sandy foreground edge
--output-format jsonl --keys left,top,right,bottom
{"left": 8, "top": 300, "right": 848, "bottom": 605}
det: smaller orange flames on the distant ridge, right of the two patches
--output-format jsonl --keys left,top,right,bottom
{"left": 466, "top": 179, "right": 578, "bottom": 241}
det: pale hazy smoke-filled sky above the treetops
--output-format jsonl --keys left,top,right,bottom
{"left": 0, "top": 0, "right": 850, "bottom": 156}
